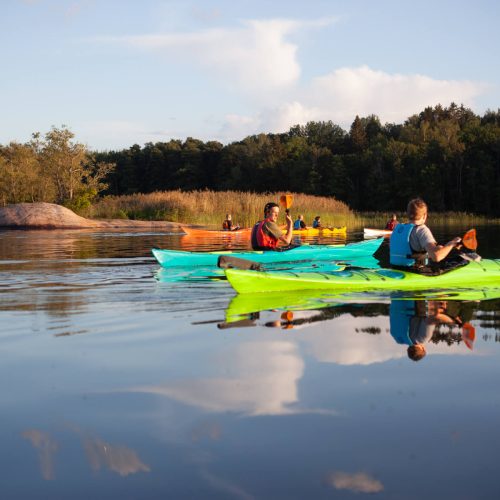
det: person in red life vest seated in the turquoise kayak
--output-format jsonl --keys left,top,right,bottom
{"left": 251, "top": 202, "right": 292, "bottom": 250}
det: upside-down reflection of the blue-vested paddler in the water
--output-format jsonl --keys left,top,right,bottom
{"left": 390, "top": 300, "right": 476, "bottom": 361}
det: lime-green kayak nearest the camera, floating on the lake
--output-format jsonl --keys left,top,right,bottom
{"left": 225, "top": 259, "right": 500, "bottom": 293}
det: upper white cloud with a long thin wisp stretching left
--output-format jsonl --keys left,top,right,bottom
{"left": 93, "top": 19, "right": 333, "bottom": 91}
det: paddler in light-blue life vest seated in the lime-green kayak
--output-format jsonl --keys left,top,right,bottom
{"left": 389, "top": 198, "right": 462, "bottom": 273}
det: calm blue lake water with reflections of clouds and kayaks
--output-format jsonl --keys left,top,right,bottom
{"left": 0, "top": 225, "right": 500, "bottom": 499}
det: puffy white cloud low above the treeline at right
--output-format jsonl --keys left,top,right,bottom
{"left": 222, "top": 66, "right": 486, "bottom": 139}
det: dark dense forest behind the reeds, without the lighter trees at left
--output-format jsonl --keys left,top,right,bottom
{"left": 93, "top": 104, "right": 500, "bottom": 216}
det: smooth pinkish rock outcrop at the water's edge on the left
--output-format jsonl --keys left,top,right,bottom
{"left": 0, "top": 203, "right": 179, "bottom": 229}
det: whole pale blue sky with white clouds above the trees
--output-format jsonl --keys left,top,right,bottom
{"left": 0, "top": 0, "right": 500, "bottom": 151}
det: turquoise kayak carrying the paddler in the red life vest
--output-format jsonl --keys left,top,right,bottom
{"left": 152, "top": 238, "right": 384, "bottom": 267}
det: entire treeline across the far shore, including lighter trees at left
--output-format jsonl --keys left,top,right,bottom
{"left": 0, "top": 104, "right": 500, "bottom": 216}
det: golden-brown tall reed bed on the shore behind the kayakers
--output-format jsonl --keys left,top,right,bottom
{"left": 89, "top": 190, "right": 354, "bottom": 227}
